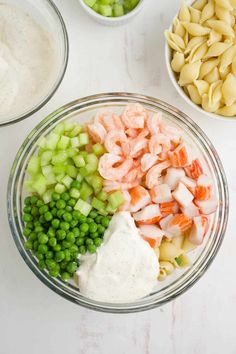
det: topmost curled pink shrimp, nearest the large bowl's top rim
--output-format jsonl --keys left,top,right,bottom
{"left": 121, "top": 103, "right": 148, "bottom": 129}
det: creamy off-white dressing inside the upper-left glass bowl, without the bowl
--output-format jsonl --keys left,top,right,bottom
{"left": 0, "top": 3, "right": 56, "bottom": 120}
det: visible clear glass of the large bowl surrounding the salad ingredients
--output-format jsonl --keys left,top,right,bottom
{"left": 7, "top": 93, "right": 229, "bottom": 313}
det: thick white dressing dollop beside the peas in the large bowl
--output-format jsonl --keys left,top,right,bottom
{"left": 77, "top": 212, "right": 159, "bottom": 303}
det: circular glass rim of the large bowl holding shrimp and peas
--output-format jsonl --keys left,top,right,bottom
{"left": 7, "top": 92, "right": 229, "bottom": 313}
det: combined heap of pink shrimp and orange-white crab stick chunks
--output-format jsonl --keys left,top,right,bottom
{"left": 88, "top": 104, "right": 218, "bottom": 248}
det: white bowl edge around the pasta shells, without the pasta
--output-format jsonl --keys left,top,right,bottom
{"left": 165, "top": 15, "right": 235, "bottom": 121}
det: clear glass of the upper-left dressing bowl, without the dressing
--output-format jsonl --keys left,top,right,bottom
{"left": 0, "top": 0, "right": 69, "bottom": 127}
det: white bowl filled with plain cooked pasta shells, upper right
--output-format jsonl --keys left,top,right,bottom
{"left": 165, "top": 0, "right": 236, "bottom": 119}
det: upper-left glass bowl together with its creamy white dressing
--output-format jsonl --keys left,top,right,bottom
{"left": 0, "top": 0, "right": 68, "bottom": 125}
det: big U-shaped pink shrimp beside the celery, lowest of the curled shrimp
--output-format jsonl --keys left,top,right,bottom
{"left": 98, "top": 153, "right": 133, "bottom": 181}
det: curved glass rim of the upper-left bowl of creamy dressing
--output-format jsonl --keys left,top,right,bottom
{"left": 0, "top": 0, "right": 69, "bottom": 128}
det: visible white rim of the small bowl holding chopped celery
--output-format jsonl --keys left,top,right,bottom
{"left": 79, "top": 0, "right": 146, "bottom": 26}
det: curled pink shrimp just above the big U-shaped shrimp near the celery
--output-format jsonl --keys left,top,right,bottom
{"left": 104, "top": 130, "right": 128, "bottom": 155}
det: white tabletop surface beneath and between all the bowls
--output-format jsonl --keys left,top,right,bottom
{"left": 0, "top": 0, "right": 236, "bottom": 354}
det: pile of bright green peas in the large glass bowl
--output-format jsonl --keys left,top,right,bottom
{"left": 23, "top": 192, "right": 111, "bottom": 281}
